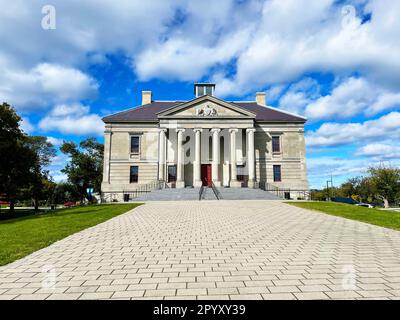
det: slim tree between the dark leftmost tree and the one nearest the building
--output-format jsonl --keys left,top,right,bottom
{"left": 26, "top": 136, "right": 56, "bottom": 211}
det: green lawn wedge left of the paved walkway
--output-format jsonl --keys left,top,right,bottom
{"left": 0, "top": 204, "right": 139, "bottom": 266}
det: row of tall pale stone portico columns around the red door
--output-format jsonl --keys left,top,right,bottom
{"left": 158, "top": 122, "right": 256, "bottom": 188}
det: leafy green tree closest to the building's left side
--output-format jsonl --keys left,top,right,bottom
{"left": 61, "top": 138, "right": 104, "bottom": 201}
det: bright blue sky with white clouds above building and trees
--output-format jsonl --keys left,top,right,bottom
{"left": 0, "top": 0, "right": 400, "bottom": 187}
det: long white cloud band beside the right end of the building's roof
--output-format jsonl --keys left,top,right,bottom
{"left": 306, "top": 112, "right": 400, "bottom": 148}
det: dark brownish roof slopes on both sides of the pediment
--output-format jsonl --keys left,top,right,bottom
{"left": 103, "top": 101, "right": 306, "bottom": 123}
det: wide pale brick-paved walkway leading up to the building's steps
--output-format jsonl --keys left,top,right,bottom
{"left": 0, "top": 201, "right": 400, "bottom": 299}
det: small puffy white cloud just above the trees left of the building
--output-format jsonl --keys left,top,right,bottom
{"left": 39, "top": 104, "right": 104, "bottom": 136}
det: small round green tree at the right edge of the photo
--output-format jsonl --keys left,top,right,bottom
{"left": 368, "top": 165, "right": 400, "bottom": 208}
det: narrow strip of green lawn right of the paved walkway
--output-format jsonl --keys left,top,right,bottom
{"left": 287, "top": 202, "right": 400, "bottom": 230}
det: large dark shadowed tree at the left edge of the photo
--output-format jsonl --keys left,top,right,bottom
{"left": 0, "top": 103, "right": 35, "bottom": 212}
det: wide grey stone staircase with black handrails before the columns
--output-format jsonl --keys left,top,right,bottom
{"left": 130, "top": 187, "right": 282, "bottom": 202}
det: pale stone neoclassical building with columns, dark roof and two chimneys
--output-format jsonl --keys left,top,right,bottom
{"left": 102, "top": 83, "right": 308, "bottom": 201}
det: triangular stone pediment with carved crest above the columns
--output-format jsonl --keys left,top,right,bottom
{"left": 157, "top": 95, "right": 256, "bottom": 118}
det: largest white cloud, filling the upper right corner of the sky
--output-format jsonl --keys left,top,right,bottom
{"left": 211, "top": 0, "right": 400, "bottom": 94}
